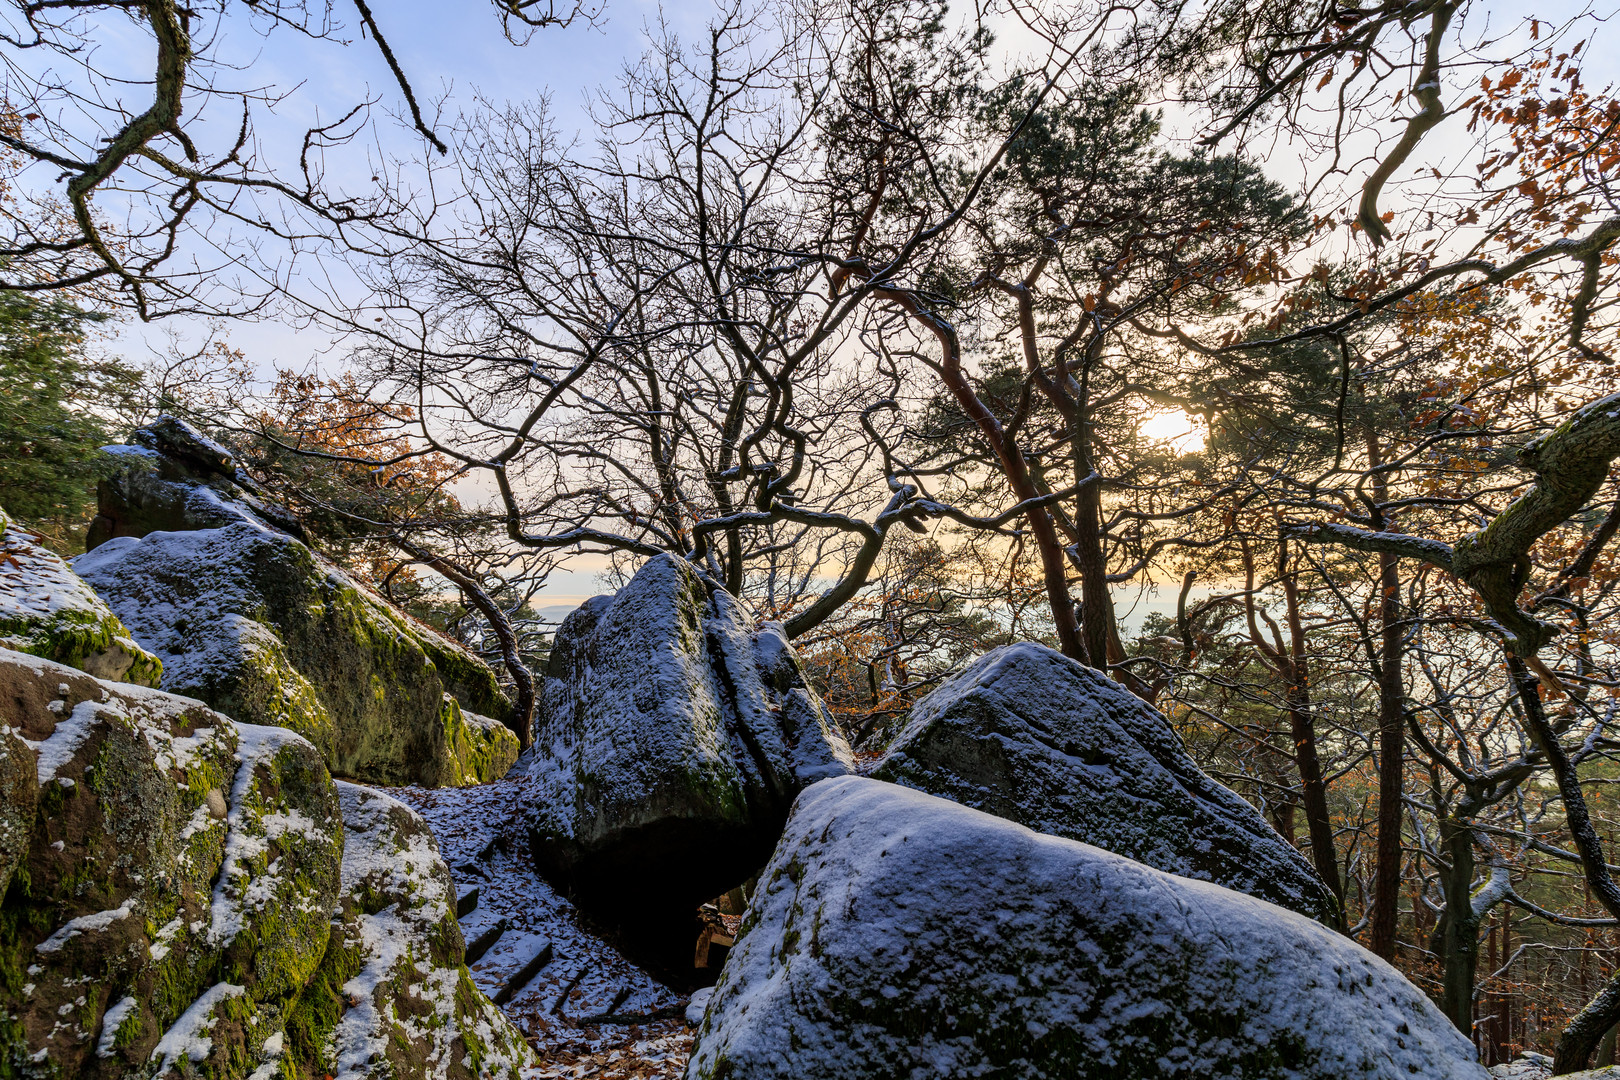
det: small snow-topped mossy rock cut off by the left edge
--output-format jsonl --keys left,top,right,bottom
{"left": 0, "top": 508, "right": 164, "bottom": 687}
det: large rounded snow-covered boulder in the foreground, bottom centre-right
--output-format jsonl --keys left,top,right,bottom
{"left": 687, "top": 777, "right": 1489, "bottom": 1080}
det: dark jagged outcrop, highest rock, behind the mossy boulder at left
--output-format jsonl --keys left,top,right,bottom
{"left": 86, "top": 416, "right": 306, "bottom": 551}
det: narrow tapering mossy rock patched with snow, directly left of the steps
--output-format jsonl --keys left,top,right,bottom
{"left": 282, "top": 784, "right": 533, "bottom": 1080}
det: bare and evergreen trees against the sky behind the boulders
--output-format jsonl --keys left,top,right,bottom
{"left": 0, "top": 0, "right": 1620, "bottom": 1067}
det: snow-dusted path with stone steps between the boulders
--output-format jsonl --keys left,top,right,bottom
{"left": 386, "top": 767, "right": 692, "bottom": 1080}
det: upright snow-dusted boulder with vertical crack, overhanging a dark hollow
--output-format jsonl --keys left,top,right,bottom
{"left": 528, "top": 555, "right": 852, "bottom": 912}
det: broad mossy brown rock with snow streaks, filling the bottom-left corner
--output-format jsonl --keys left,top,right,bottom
{"left": 0, "top": 653, "right": 342, "bottom": 1080}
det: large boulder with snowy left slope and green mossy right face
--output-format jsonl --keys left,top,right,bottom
{"left": 75, "top": 520, "right": 518, "bottom": 787}
